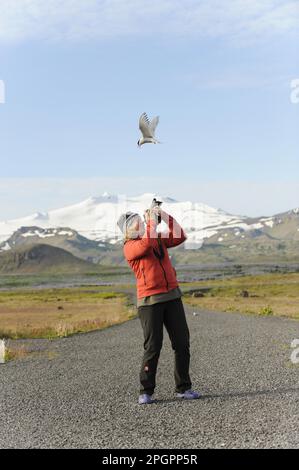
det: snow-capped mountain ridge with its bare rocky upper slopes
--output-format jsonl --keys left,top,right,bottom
{"left": 0, "top": 192, "right": 299, "bottom": 262}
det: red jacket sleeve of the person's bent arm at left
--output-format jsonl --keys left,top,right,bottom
{"left": 124, "top": 219, "right": 158, "bottom": 261}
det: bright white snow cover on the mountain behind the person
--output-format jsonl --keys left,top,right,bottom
{"left": 0, "top": 192, "right": 299, "bottom": 251}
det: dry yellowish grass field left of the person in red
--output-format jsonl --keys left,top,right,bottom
{"left": 0, "top": 286, "right": 134, "bottom": 339}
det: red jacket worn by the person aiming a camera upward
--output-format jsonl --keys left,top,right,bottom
{"left": 124, "top": 212, "right": 187, "bottom": 299}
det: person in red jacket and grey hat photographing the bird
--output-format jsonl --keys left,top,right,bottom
{"left": 117, "top": 206, "right": 200, "bottom": 404}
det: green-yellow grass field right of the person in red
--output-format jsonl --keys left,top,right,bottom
{"left": 181, "top": 273, "right": 299, "bottom": 319}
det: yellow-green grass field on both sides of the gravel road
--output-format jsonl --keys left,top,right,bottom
{"left": 0, "top": 273, "right": 299, "bottom": 339}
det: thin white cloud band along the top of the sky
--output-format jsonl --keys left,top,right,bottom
{"left": 0, "top": 0, "right": 299, "bottom": 42}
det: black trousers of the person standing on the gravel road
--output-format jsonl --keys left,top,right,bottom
{"left": 138, "top": 298, "right": 192, "bottom": 395}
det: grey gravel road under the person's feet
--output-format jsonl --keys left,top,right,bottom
{"left": 0, "top": 306, "right": 299, "bottom": 449}
